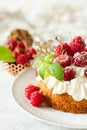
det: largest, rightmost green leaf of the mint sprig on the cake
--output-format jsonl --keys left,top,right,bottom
{"left": 46, "top": 62, "right": 64, "bottom": 80}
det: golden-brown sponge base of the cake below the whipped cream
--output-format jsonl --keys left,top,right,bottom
{"left": 38, "top": 81, "right": 87, "bottom": 113}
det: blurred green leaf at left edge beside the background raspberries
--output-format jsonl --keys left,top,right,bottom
{"left": 0, "top": 46, "right": 16, "bottom": 62}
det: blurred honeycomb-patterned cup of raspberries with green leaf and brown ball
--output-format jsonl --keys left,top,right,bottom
{"left": 0, "top": 29, "right": 37, "bottom": 75}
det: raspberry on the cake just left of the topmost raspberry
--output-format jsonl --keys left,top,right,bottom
{"left": 55, "top": 43, "right": 74, "bottom": 56}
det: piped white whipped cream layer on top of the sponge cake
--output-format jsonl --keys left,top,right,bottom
{"left": 37, "top": 66, "right": 87, "bottom": 101}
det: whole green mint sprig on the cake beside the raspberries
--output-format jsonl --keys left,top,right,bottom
{"left": 34, "top": 55, "right": 64, "bottom": 80}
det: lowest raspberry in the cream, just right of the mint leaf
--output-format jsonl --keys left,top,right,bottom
{"left": 64, "top": 67, "right": 76, "bottom": 81}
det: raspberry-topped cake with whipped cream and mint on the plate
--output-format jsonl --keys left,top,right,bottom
{"left": 36, "top": 36, "right": 87, "bottom": 113}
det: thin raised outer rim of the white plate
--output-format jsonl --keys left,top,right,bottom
{"left": 11, "top": 67, "right": 87, "bottom": 129}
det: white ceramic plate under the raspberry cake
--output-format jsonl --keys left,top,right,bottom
{"left": 12, "top": 68, "right": 87, "bottom": 129}
